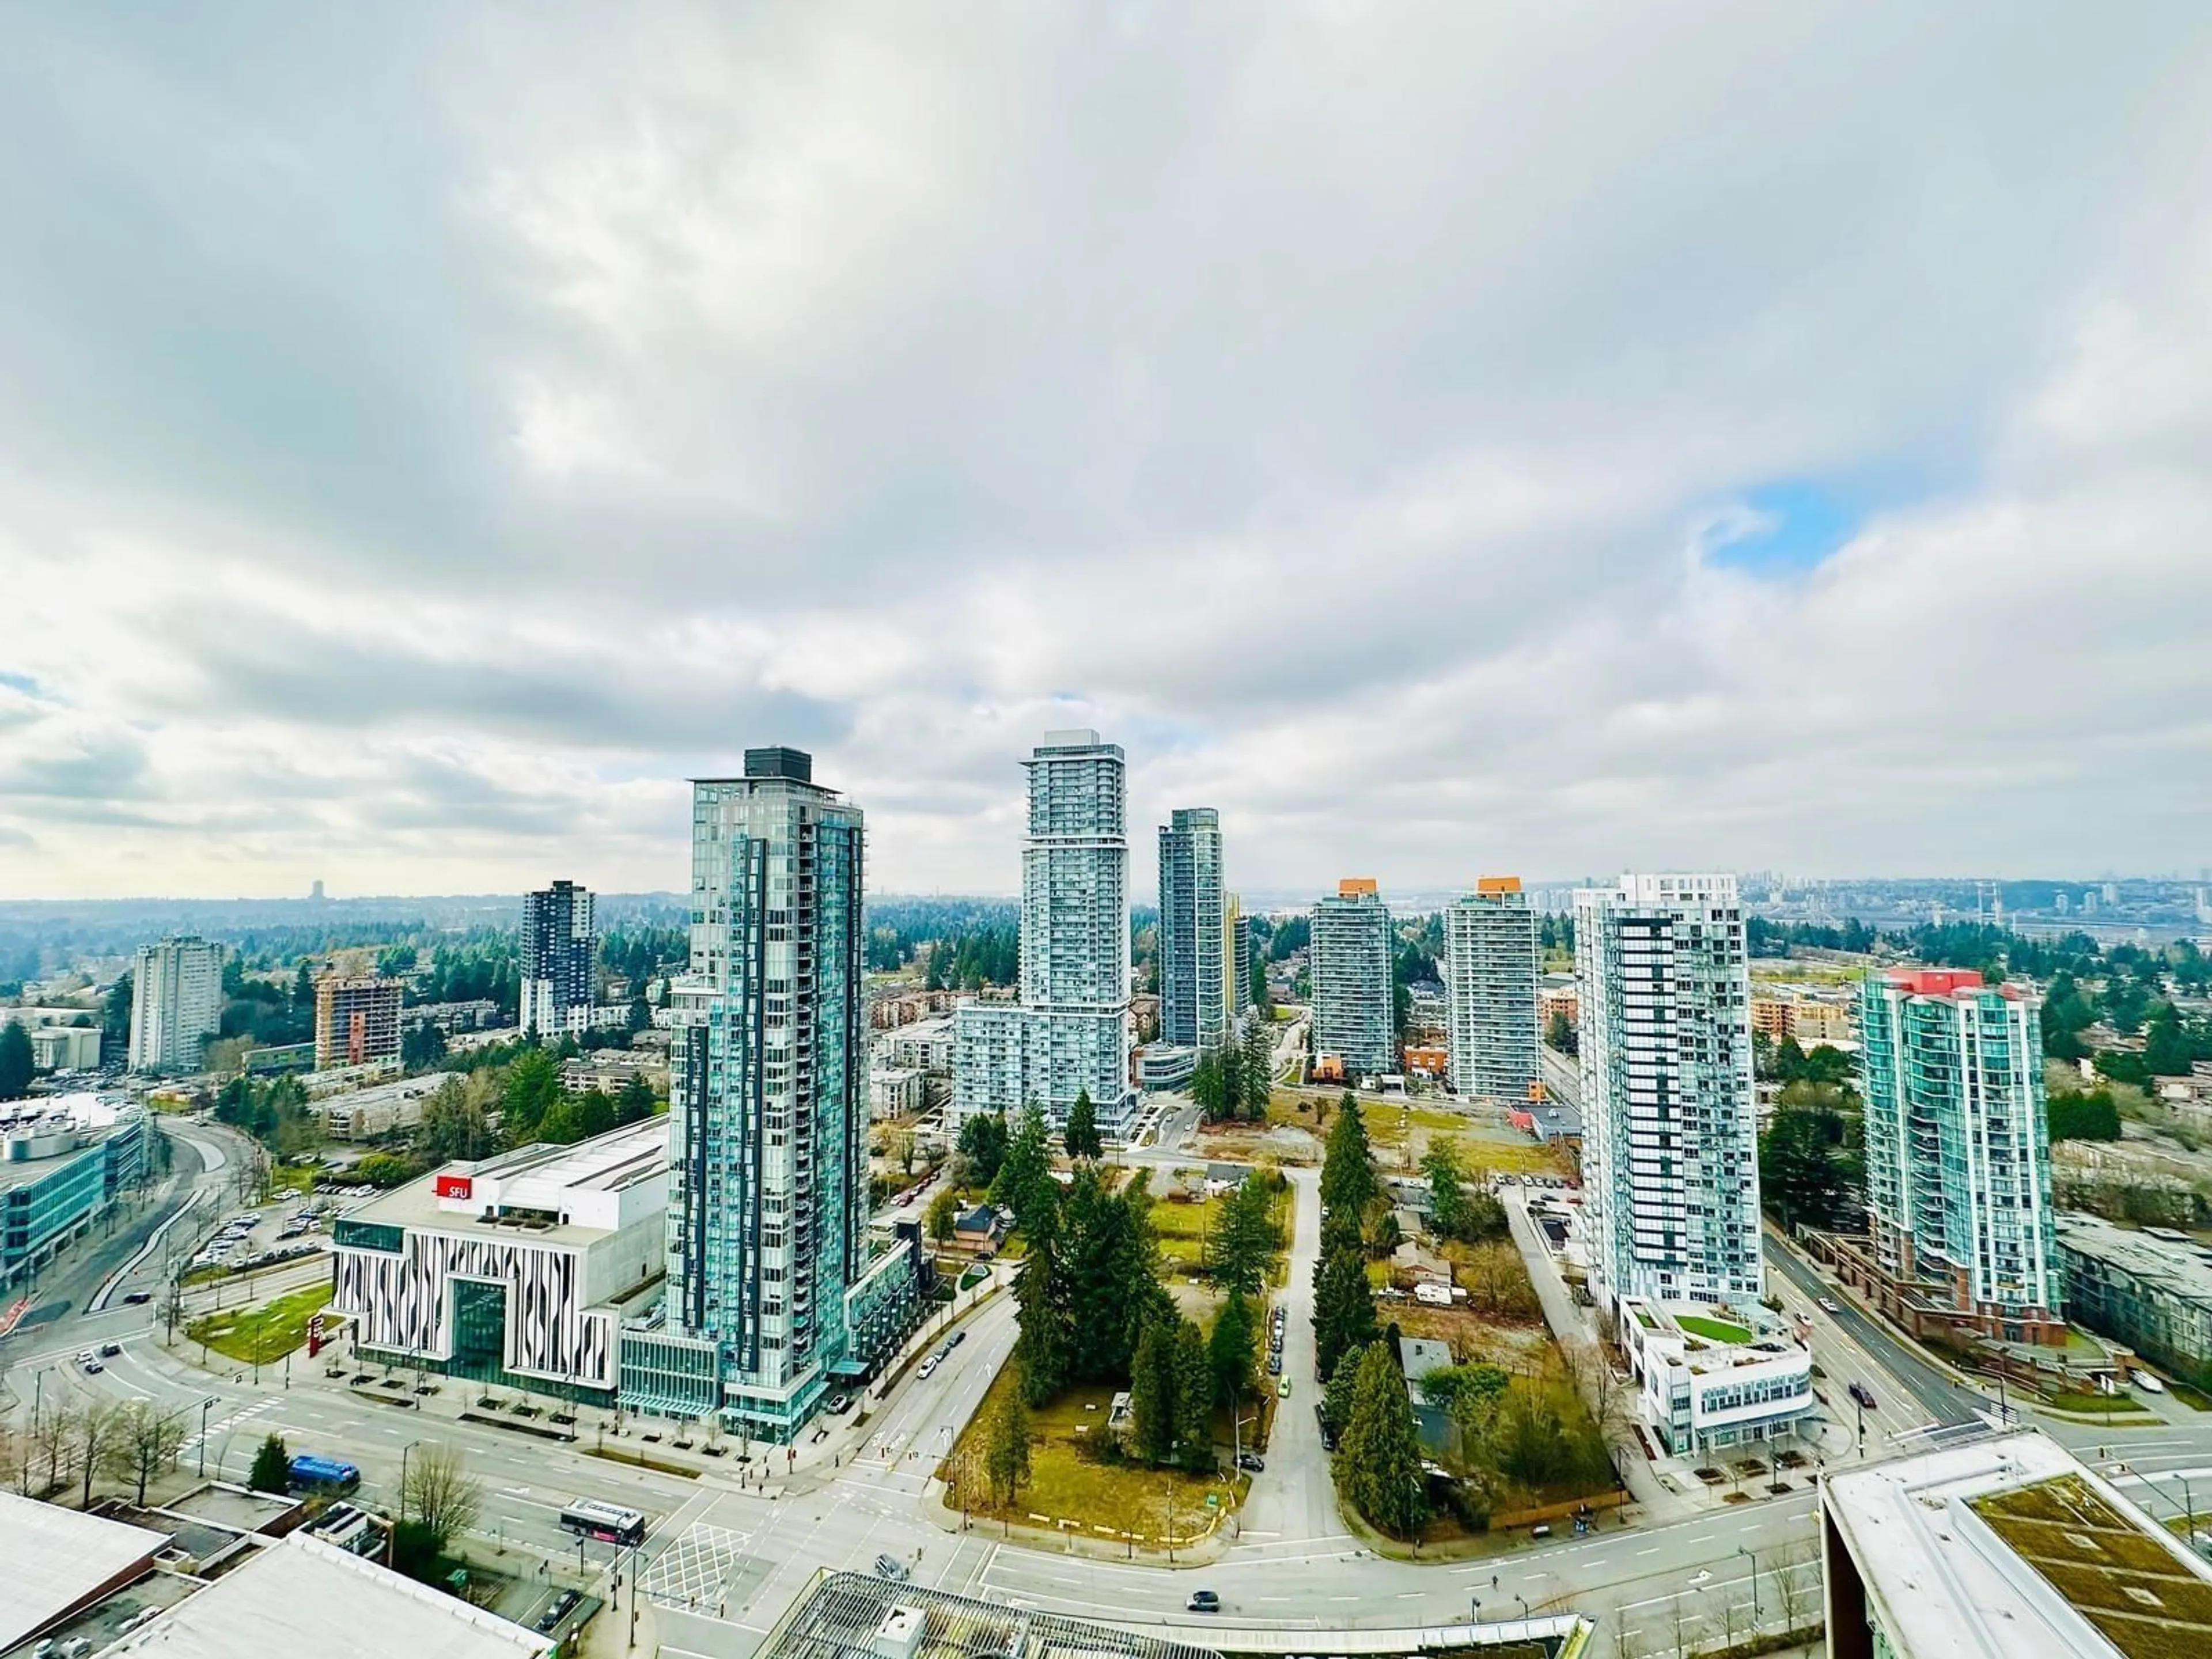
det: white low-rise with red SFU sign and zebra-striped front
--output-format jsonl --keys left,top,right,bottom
{"left": 332, "top": 1117, "right": 668, "bottom": 1404}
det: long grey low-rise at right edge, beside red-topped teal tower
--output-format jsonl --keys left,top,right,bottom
{"left": 2055, "top": 1214, "right": 2212, "bottom": 1385}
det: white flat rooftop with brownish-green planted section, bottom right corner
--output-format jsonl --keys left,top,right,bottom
{"left": 1825, "top": 1431, "right": 2212, "bottom": 1659}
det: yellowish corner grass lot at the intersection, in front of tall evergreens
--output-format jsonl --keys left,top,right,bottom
{"left": 938, "top": 1365, "right": 1248, "bottom": 1548}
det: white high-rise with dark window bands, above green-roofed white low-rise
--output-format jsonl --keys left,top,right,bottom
{"left": 1575, "top": 876, "right": 1765, "bottom": 1305}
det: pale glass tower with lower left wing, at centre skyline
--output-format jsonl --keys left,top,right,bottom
{"left": 953, "top": 730, "right": 1137, "bottom": 1126}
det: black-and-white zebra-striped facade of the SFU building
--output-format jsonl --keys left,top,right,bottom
{"left": 332, "top": 1228, "right": 615, "bottom": 1389}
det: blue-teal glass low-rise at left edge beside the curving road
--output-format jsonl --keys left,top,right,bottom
{"left": 0, "top": 1095, "right": 150, "bottom": 1292}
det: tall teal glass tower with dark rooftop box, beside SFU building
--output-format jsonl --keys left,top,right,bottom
{"left": 664, "top": 748, "right": 867, "bottom": 1440}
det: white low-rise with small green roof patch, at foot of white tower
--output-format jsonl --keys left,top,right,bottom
{"left": 1619, "top": 1296, "right": 1816, "bottom": 1458}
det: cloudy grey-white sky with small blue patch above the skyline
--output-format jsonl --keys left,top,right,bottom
{"left": 0, "top": 0, "right": 2212, "bottom": 911}
